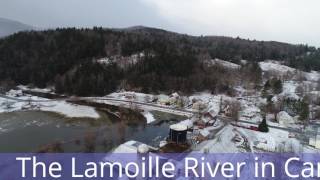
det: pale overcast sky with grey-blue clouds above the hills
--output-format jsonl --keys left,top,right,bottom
{"left": 0, "top": 0, "right": 320, "bottom": 47}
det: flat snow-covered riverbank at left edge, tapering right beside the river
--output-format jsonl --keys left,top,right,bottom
{"left": 0, "top": 90, "right": 100, "bottom": 118}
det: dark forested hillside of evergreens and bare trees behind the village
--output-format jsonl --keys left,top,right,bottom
{"left": 0, "top": 27, "right": 320, "bottom": 96}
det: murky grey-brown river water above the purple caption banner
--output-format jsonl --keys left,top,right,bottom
{"left": 0, "top": 111, "right": 185, "bottom": 152}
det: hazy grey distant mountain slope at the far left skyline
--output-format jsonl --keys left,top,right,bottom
{"left": 0, "top": 18, "right": 34, "bottom": 37}
